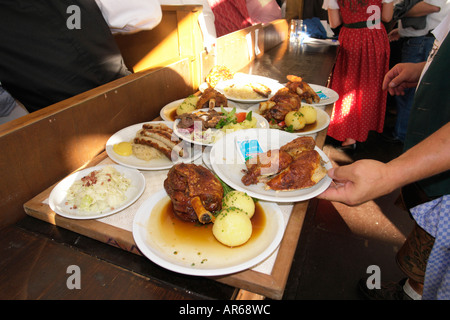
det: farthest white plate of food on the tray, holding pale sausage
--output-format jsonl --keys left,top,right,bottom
{"left": 215, "top": 74, "right": 284, "bottom": 103}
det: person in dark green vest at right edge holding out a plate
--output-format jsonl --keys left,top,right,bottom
{"left": 318, "top": 16, "right": 450, "bottom": 300}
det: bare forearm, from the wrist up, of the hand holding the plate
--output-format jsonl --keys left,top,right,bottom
{"left": 386, "top": 122, "right": 450, "bottom": 189}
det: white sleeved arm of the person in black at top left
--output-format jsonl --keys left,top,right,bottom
{"left": 95, "top": 0, "right": 162, "bottom": 33}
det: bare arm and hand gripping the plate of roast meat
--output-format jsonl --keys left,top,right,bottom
{"left": 318, "top": 122, "right": 450, "bottom": 205}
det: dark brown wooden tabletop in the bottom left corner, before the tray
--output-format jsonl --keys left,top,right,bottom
{"left": 0, "top": 226, "right": 207, "bottom": 300}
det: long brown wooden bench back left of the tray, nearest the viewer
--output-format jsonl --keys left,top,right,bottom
{"left": 0, "top": 58, "right": 194, "bottom": 229}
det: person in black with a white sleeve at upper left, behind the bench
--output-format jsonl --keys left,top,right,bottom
{"left": 0, "top": 0, "right": 162, "bottom": 113}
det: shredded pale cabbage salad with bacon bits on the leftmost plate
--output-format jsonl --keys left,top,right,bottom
{"left": 67, "top": 166, "right": 131, "bottom": 214}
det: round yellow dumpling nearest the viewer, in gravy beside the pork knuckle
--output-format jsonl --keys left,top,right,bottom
{"left": 212, "top": 208, "right": 253, "bottom": 247}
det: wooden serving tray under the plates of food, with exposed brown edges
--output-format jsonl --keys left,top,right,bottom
{"left": 24, "top": 110, "right": 329, "bottom": 300}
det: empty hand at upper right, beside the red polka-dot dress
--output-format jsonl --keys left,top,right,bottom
{"left": 383, "top": 62, "right": 425, "bottom": 96}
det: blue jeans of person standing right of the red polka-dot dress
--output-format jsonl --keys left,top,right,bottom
{"left": 394, "top": 36, "right": 434, "bottom": 141}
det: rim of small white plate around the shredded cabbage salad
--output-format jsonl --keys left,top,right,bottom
{"left": 49, "top": 165, "right": 145, "bottom": 220}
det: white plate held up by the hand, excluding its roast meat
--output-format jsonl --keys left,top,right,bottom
{"left": 210, "top": 129, "right": 332, "bottom": 202}
